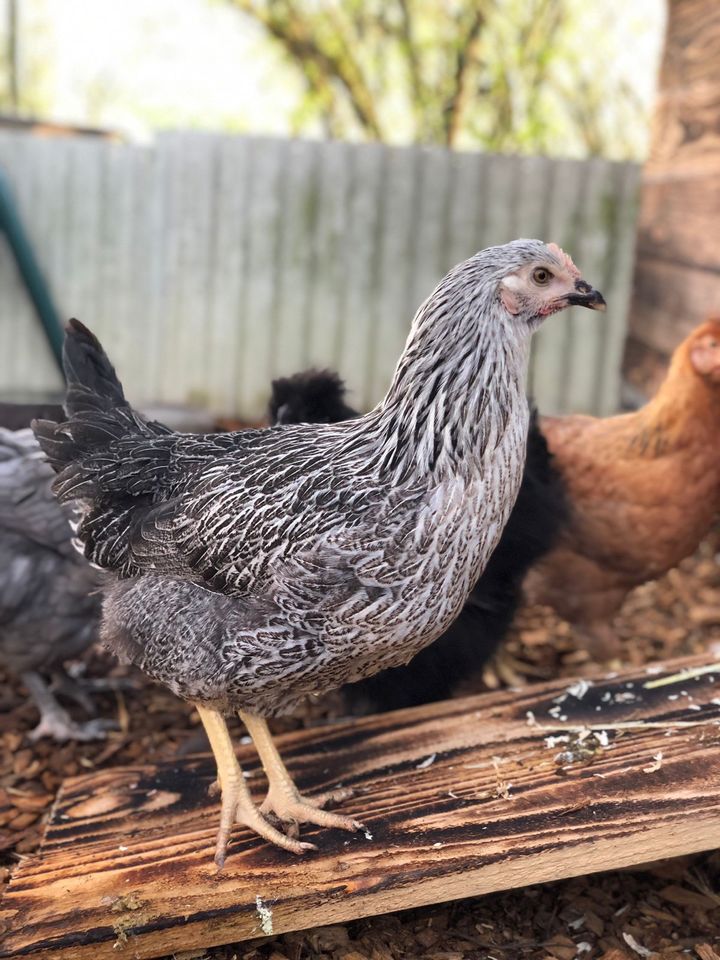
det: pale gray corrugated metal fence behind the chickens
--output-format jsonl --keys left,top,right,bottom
{"left": 0, "top": 133, "right": 639, "bottom": 418}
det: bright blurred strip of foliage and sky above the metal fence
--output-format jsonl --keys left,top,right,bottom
{"left": 0, "top": 0, "right": 665, "bottom": 159}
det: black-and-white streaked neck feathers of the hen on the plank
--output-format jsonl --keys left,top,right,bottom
{"left": 338, "top": 268, "right": 531, "bottom": 483}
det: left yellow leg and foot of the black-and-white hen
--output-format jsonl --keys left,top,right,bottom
{"left": 195, "top": 703, "right": 316, "bottom": 867}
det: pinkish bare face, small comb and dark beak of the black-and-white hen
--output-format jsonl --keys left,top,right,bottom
{"left": 500, "top": 243, "right": 605, "bottom": 317}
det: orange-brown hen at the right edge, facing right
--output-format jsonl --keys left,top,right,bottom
{"left": 526, "top": 318, "right": 720, "bottom": 659}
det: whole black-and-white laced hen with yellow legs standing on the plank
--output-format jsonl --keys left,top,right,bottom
{"left": 35, "top": 240, "right": 604, "bottom": 865}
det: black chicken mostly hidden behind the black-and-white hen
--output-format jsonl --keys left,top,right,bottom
{"left": 268, "top": 370, "right": 568, "bottom": 714}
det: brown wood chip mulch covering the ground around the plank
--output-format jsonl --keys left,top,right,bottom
{"left": 0, "top": 528, "right": 720, "bottom": 960}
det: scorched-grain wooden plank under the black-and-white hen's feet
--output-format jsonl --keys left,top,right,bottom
{"left": 0, "top": 658, "right": 720, "bottom": 960}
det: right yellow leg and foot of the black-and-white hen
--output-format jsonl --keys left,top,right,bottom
{"left": 240, "top": 711, "right": 364, "bottom": 832}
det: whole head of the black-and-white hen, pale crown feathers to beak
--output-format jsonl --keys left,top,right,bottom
{"left": 498, "top": 240, "right": 605, "bottom": 327}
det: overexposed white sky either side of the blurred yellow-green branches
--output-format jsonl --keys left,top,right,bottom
{"left": 7, "top": 0, "right": 665, "bottom": 150}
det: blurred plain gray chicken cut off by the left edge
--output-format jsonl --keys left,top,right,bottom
{"left": 0, "top": 428, "right": 105, "bottom": 740}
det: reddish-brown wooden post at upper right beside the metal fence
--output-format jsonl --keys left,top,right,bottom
{"left": 630, "top": 0, "right": 720, "bottom": 378}
